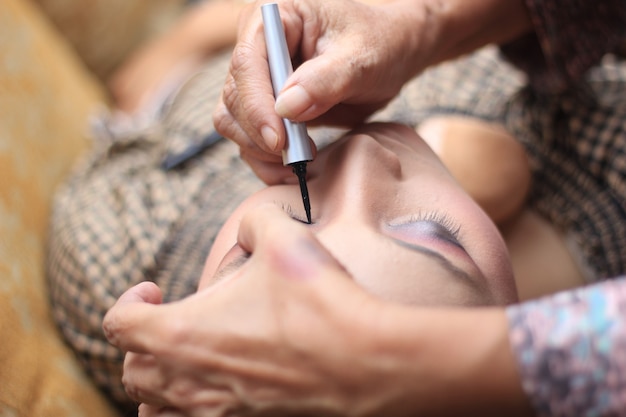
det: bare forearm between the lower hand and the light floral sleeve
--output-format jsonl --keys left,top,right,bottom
{"left": 360, "top": 308, "right": 532, "bottom": 416}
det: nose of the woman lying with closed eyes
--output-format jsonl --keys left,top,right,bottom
{"left": 311, "top": 134, "right": 402, "bottom": 223}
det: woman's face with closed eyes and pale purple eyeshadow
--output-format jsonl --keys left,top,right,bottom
{"left": 201, "top": 124, "right": 516, "bottom": 305}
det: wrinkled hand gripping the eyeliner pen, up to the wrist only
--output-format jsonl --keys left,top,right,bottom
{"left": 213, "top": 0, "right": 428, "bottom": 184}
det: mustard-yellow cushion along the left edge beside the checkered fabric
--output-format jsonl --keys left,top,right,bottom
{"left": 0, "top": 0, "right": 115, "bottom": 417}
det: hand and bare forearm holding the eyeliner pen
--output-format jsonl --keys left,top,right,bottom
{"left": 213, "top": 0, "right": 532, "bottom": 184}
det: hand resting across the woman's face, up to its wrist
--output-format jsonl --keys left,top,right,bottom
{"left": 104, "top": 207, "right": 392, "bottom": 416}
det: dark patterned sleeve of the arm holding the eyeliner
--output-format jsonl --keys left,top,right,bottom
{"left": 502, "top": 0, "right": 626, "bottom": 92}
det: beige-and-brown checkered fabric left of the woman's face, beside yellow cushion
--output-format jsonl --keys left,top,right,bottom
{"left": 47, "top": 50, "right": 262, "bottom": 414}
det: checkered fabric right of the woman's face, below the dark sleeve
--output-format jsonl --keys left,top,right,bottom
{"left": 392, "top": 48, "right": 626, "bottom": 280}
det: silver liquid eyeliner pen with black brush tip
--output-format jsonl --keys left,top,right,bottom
{"left": 261, "top": 3, "right": 313, "bottom": 224}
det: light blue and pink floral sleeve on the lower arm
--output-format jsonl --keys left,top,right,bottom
{"left": 507, "top": 277, "right": 626, "bottom": 417}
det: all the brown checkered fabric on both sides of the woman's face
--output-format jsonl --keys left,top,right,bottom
{"left": 48, "top": 48, "right": 626, "bottom": 410}
